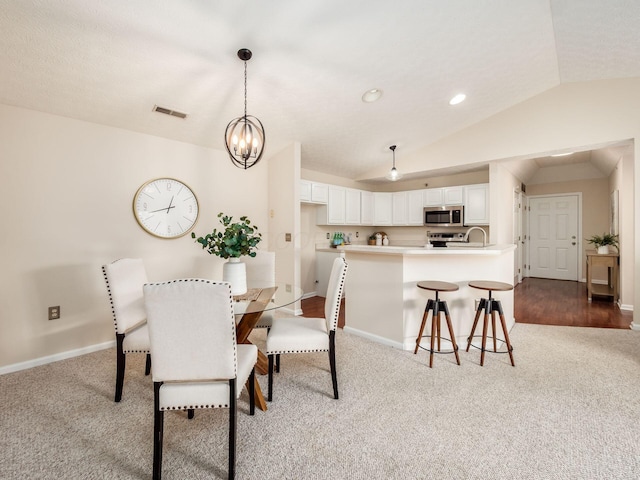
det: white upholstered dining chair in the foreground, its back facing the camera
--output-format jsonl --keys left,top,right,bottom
{"left": 144, "top": 279, "right": 258, "bottom": 480}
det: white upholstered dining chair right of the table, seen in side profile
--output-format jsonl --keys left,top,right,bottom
{"left": 266, "top": 257, "right": 347, "bottom": 401}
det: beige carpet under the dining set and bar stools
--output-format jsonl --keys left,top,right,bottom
{"left": 0, "top": 324, "right": 640, "bottom": 480}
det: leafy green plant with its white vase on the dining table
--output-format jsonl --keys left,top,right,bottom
{"left": 191, "top": 212, "right": 262, "bottom": 295}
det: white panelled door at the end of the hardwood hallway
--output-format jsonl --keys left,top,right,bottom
{"left": 529, "top": 195, "right": 580, "bottom": 281}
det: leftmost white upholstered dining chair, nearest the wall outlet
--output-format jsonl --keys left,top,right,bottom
{"left": 102, "top": 258, "right": 151, "bottom": 402}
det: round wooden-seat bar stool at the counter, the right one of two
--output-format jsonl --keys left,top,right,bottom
{"left": 467, "top": 280, "right": 516, "bottom": 367}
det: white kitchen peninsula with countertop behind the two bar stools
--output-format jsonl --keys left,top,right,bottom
{"left": 342, "top": 245, "right": 516, "bottom": 350}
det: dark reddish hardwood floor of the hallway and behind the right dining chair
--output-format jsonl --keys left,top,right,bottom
{"left": 302, "top": 278, "right": 633, "bottom": 328}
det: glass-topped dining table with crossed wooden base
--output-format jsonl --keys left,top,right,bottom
{"left": 234, "top": 283, "right": 303, "bottom": 411}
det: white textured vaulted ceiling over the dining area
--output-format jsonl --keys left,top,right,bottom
{"left": 0, "top": 0, "right": 640, "bottom": 182}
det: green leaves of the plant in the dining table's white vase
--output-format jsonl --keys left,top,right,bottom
{"left": 191, "top": 212, "right": 262, "bottom": 258}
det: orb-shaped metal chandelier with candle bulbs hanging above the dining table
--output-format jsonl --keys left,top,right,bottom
{"left": 224, "top": 48, "right": 266, "bottom": 170}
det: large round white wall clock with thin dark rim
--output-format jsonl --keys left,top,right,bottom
{"left": 133, "top": 178, "right": 198, "bottom": 238}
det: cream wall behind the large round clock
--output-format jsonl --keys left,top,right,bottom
{"left": 0, "top": 105, "right": 274, "bottom": 368}
